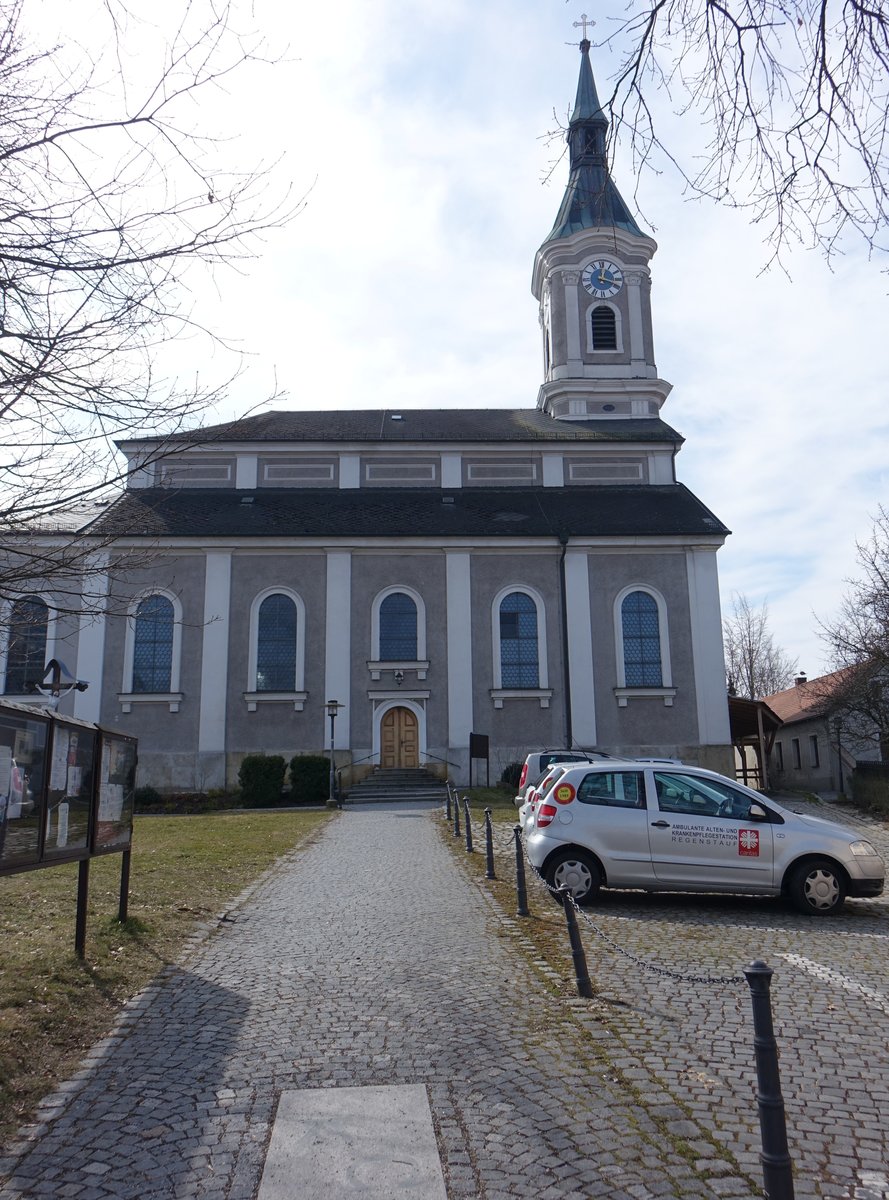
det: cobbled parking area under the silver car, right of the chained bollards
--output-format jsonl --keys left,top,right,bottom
{"left": 498, "top": 797, "right": 889, "bottom": 1200}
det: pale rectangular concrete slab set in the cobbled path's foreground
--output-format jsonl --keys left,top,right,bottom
{"left": 257, "top": 1084, "right": 446, "bottom": 1200}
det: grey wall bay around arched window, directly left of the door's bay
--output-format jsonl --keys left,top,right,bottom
{"left": 226, "top": 551, "right": 326, "bottom": 758}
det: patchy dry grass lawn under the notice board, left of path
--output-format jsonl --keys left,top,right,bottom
{"left": 0, "top": 811, "right": 329, "bottom": 1144}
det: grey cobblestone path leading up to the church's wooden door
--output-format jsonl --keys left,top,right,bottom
{"left": 0, "top": 806, "right": 758, "bottom": 1200}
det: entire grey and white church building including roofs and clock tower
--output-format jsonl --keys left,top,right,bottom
{"left": 2, "top": 41, "right": 732, "bottom": 790}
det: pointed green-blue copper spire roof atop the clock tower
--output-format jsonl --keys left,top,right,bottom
{"left": 546, "top": 38, "right": 645, "bottom": 241}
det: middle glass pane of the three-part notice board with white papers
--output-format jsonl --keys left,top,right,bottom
{"left": 43, "top": 721, "right": 96, "bottom": 858}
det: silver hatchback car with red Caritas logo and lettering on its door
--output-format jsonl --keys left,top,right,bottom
{"left": 524, "top": 760, "right": 885, "bottom": 916}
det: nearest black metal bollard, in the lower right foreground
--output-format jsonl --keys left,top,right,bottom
{"left": 744, "top": 959, "right": 793, "bottom": 1200}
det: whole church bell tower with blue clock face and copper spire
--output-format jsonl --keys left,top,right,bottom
{"left": 531, "top": 35, "right": 671, "bottom": 421}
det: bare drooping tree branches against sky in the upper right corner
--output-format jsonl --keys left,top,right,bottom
{"left": 585, "top": 0, "right": 889, "bottom": 256}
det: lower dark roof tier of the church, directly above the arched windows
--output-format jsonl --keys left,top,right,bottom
{"left": 86, "top": 484, "right": 728, "bottom": 541}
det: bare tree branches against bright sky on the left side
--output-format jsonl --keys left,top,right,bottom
{"left": 0, "top": 0, "right": 302, "bottom": 611}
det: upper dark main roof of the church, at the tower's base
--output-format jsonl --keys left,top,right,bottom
{"left": 119, "top": 408, "right": 683, "bottom": 445}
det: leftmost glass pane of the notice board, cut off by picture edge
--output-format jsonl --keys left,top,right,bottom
{"left": 0, "top": 709, "right": 48, "bottom": 868}
